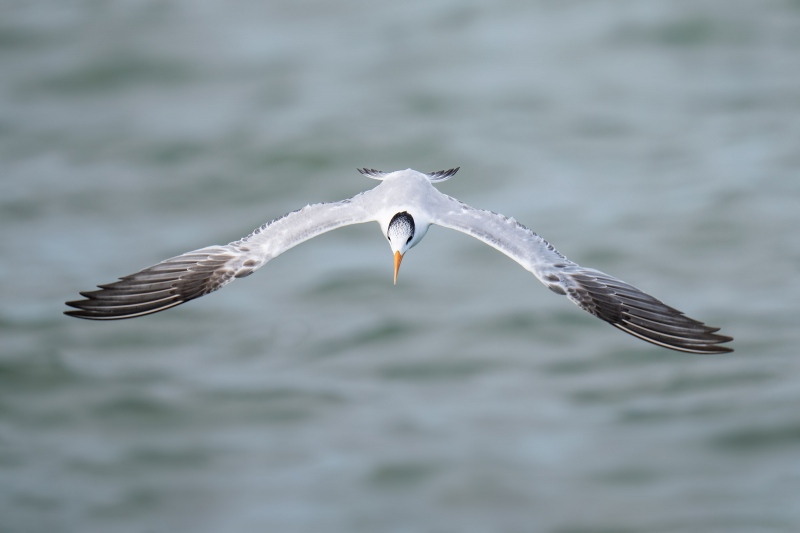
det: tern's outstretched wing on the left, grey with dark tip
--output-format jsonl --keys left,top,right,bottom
{"left": 64, "top": 193, "right": 375, "bottom": 320}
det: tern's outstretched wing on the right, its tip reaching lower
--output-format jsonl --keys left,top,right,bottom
{"left": 432, "top": 194, "right": 733, "bottom": 354}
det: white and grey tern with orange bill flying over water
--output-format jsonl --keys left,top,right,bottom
{"left": 64, "top": 167, "right": 733, "bottom": 354}
